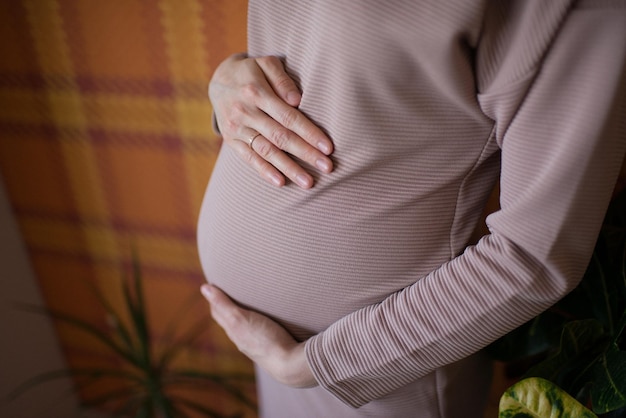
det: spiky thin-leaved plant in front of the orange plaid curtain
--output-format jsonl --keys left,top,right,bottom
{"left": 9, "top": 257, "right": 256, "bottom": 418}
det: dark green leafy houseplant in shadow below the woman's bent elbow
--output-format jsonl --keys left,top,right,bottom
{"left": 489, "top": 191, "right": 626, "bottom": 417}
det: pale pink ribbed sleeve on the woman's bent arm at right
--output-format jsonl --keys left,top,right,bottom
{"left": 306, "top": 1, "right": 626, "bottom": 407}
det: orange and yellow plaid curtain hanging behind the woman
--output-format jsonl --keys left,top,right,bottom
{"left": 0, "top": 0, "right": 250, "bottom": 413}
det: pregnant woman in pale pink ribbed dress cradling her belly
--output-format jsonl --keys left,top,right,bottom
{"left": 198, "top": 0, "right": 626, "bottom": 418}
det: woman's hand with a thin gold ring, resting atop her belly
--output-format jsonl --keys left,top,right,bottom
{"left": 209, "top": 54, "right": 333, "bottom": 189}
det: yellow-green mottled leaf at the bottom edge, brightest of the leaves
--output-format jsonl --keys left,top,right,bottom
{"left": 499, "top": 377, "right": 597, "bottom": 418}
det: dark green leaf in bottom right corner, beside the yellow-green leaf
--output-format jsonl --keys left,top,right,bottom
{"left": 591, "top": 345, "right": 626, "bottom": 414}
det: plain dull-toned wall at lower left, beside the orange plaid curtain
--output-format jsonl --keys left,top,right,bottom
{"left": 0, "top": 177, "right": 105, "bottom": 418}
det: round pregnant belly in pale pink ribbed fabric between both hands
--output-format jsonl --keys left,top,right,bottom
{"left": 198, "top": 149, "right": 449, "bottom": 339}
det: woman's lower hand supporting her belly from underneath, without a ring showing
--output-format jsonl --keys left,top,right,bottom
{"left": 201, "top": 284, "right": 317, "bottom": 388}
